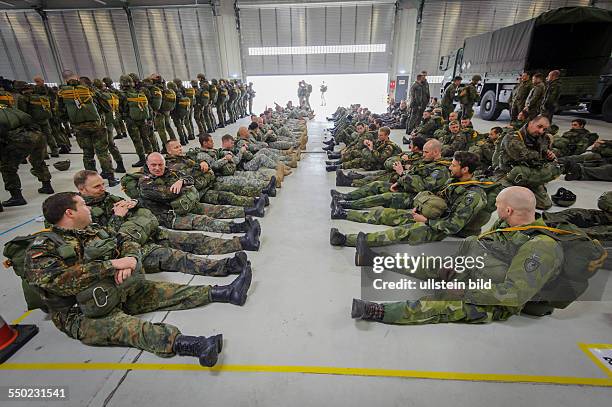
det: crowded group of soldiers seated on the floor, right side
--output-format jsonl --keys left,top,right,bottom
{"left": 325, "top": 109, "right": 612, "bottom": 324}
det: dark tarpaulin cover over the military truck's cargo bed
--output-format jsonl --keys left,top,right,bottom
{"left": 461, "top": 7, "right": 612, "bottom": 74}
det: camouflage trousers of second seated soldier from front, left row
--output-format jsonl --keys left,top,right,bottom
{"left": 142, "top": 242, "right": 239, "bottom": 277}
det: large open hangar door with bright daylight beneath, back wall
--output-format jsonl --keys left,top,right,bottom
{"left": 236, "top": 0, "right": 396, "bottom": 112}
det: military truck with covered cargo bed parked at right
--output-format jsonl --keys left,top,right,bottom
{"left": 439, "top": 7, "right": 612, "bottom": 120}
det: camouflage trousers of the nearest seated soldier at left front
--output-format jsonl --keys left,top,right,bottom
{"left": 51, "top": 280, "right": 210, "bottom": 357}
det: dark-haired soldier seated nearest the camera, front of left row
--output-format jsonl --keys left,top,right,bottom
{"left": 24, "top": 192, "right": 252, "bottom": 366}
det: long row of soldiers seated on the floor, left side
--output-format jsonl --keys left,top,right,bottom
{"left": 4, "top": 107, "right": 307, "bottom": 366}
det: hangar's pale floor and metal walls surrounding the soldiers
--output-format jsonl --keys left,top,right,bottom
{"left": 0, "top": 0, "right": 612, "bottom": 407}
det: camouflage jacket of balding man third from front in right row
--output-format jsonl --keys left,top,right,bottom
{"left": 397, "top": 159, "right": 450, "bottom": 194}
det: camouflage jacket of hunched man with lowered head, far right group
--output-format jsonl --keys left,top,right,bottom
{"left": 499, "top": 125, "right": 550, "bottom": 171}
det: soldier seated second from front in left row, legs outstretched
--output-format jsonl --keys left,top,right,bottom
{"left": 73, "top": 170, "right": 253, "bottom": 264}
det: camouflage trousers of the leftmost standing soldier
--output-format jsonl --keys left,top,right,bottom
{"left": 0, "top": 130, "right": 51, "bottom": 191}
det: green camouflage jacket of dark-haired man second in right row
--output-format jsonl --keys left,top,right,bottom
{"left": 427, "top": 179, "right": 487, "bottom": 236}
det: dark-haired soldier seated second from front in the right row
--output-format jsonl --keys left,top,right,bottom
{"left": 330, "top": 151, "right": 490, "bottom": 246}
